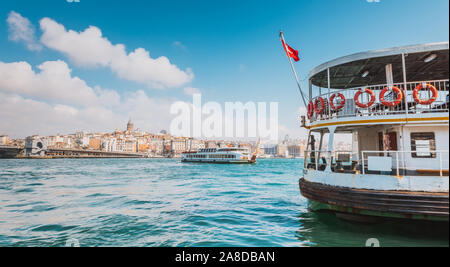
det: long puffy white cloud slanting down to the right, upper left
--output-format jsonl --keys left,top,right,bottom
{"left": 40, "top": 18, "right": 194, "bottom": 89}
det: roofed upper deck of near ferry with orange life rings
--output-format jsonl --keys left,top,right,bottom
{"left": 307, "top": 42, "right": 449, "bottom": 129}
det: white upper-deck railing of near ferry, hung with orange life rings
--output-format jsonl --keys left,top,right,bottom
{"left": 311, "top": 79, "right": 449, "bottom": 122}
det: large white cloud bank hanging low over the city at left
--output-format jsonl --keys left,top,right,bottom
{"left": 0, "top": 61, "right": 175, "bottom": 137}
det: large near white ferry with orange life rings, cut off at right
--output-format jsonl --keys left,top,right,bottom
{"left": 299, "top": 42, "right": 449, "bottom": 224}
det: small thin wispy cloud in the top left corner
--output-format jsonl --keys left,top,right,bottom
{"left": 6, "top": 11, "right": 42, "bottom": 51}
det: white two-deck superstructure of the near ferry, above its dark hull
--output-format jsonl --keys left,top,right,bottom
{"left": 304, "top": 42, "right": 449, "bottom": 192}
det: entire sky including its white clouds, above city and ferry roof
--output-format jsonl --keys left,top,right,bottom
{"left": 0, "top": 0, "right": 449, "bottom": 138}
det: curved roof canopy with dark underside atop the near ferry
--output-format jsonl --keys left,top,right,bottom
{"left": 309, "top": 42, "right": 449, "bottom": 89}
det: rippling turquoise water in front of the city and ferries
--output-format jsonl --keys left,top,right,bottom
{"left": 0, "top": 159, "right": 449, "bottom": 247}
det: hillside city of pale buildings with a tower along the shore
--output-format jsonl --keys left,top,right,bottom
{"left": 0, "top": 119, "right": 351, "bottom": 158}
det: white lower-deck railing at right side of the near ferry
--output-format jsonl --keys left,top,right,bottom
{"left": 361, "top": 150, "right": 449, "bottom": 177}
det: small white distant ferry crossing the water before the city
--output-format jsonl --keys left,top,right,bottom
{"left": 181, "top": 147, "right": 256, "bottom": 164}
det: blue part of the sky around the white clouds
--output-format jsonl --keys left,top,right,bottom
{"left": 0, "top": 0, "right": 449, "bottom": 136}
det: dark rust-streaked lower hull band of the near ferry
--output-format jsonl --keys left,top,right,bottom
{"left": 299, "top": 178, "right": 449, "bottom": 218}
